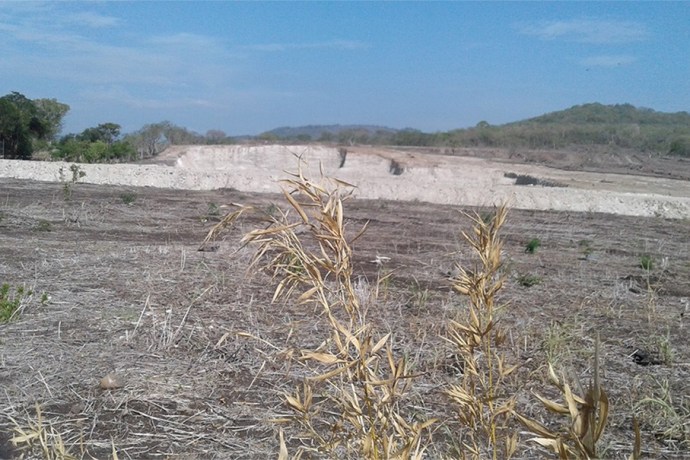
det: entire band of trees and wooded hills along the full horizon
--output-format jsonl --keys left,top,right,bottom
{"left": 0, "top": 92, "right": 690, "bottom": 163}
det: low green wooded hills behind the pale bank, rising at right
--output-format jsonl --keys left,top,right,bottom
{"left": 259, "top": 103, "right": 690, "bottom": 157}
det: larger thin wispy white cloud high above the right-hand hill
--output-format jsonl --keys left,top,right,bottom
{"left": 518, "top": 19, "right": 649, "bottom": 44}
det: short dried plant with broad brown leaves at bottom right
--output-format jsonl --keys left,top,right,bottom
{"left": 515, "top": 337, "right": 628, "bottom": 460}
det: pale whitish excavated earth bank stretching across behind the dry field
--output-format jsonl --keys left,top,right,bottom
{"left": 0, "top": 145, "right": 690, "bottom": 218}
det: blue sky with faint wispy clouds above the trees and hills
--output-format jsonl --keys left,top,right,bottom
{"left": 0, "top": 0, "right": 690, "bottom": 135}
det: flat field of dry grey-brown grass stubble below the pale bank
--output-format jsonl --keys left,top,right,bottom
{"left": 0, "top": 176, "right": 690, "bottom": 460}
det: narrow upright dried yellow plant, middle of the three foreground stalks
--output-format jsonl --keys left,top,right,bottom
{"left": 445, "top": 205, "right": 517, "bottom": 459}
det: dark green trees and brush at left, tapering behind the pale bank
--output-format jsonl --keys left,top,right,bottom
{"left": 0, "top": 92, "right": 234, "bottom": 163}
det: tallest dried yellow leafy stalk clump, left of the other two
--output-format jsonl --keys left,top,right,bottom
{"left": 243, "top": 168, "right": 434, "bottom": 459}
